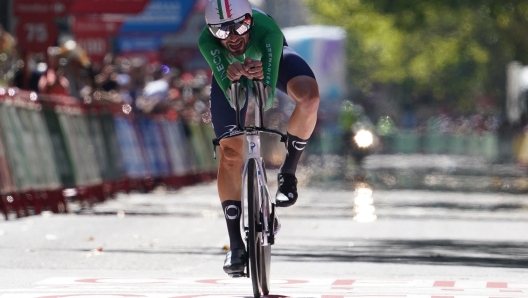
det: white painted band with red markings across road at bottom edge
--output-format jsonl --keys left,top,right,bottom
{"left": 0, "top": 277, "right": 528, "bottom": 298}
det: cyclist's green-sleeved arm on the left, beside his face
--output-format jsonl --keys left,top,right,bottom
{"left": 198, "top": 28, "right": 231, "bottom": 98}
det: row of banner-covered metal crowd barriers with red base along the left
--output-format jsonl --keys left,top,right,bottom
{"left": 0, "top": 88, "right": 217, "bottom": 219}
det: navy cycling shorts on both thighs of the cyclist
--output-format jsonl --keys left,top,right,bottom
{"left": 210, "top": 46, "right": 315, "bottom": 137}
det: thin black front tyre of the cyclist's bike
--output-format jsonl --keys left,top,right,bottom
{"left": 247, "top": 159, "right": 262, "bottom": 298}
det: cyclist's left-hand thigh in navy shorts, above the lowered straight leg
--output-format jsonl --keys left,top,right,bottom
{"left": 209, "top": 77, "right": 247, "bottom": 137}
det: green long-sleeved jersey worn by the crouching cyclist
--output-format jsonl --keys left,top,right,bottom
{"left": 198, "top": 9, "right": 284, "bottom": 109}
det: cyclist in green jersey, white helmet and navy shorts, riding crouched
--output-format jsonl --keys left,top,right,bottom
{"left": 199, "top": 0, "right": 319, "bottom": 276}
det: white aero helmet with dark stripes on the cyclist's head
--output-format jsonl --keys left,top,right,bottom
{"left": 205, "top": 0, "right": 253, "bottom": 24}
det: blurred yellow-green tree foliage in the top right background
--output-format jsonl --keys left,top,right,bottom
{"left": 305, "top": 0, "right": 528, "bottom": 110}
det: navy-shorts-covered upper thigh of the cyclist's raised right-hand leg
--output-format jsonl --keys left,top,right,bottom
{"left": 277, "top": 46, "right": 315, "bottom": 93}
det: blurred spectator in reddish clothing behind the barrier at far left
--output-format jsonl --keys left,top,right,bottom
{"left": 38, "top": 47, "right": 70, "bottom": 95}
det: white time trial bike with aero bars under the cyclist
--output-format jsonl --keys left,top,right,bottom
{"left": 213, "top": 79, "right": 287, "bottom": 298}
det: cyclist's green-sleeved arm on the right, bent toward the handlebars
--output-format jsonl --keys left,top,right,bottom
{"left": 261, "top": 33, "right": 284, "bottom": 110}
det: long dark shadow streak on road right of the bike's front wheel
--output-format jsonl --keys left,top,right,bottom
{"left": 273, "top": 239, "right": 528, "bottom": 268}
